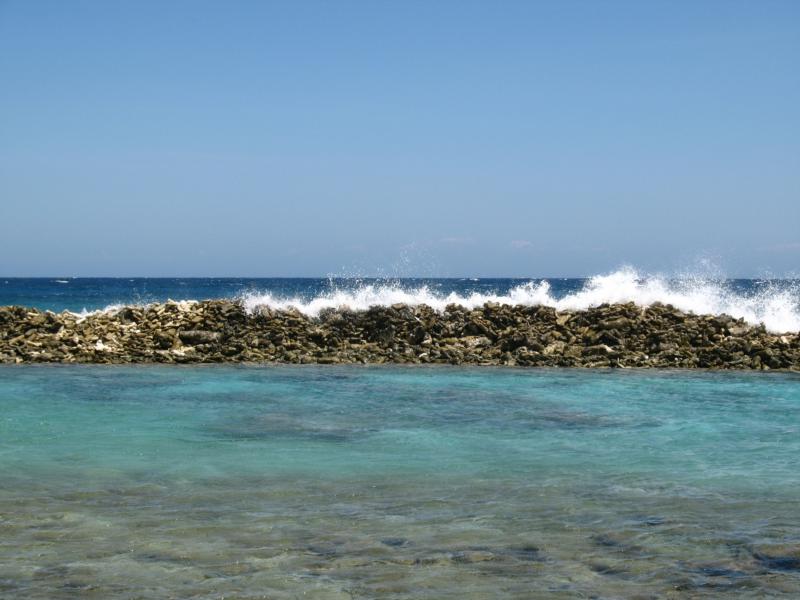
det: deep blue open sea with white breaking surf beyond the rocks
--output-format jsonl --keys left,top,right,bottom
{"left": 9, "top": 267, "right": 800, "bottom": 333}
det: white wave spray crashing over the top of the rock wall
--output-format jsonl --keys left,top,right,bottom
{"left": 241, "top": 268, "right": 800, "bottom": 333}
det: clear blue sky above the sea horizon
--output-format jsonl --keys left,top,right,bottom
{"left": 0, "top": 0, "right": 800, "bottom": 277}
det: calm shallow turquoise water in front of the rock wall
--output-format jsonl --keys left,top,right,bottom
{"left": 0, "top": 366, "right": 800, "bottom": 599}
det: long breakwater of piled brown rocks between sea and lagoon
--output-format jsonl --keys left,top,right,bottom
{"left": 0, "top": 300, "right": 800, "bottom": 370}
